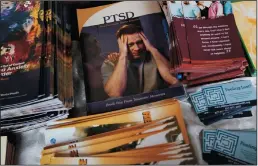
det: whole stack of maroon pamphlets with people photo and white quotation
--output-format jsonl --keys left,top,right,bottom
{"left": 159, "top": 1, "right": 254, "bottom": 85}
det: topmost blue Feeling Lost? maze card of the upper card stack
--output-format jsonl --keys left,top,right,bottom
{"left": 202, "top": 80, "right": 256, "bottom": 111}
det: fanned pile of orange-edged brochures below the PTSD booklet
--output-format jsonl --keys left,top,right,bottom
{"left": 41, "top": 99, "right": 197, "bottom": 165}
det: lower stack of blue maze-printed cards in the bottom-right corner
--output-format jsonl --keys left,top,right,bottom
{"left": 200, "top": 129, "right": 257, "bottom": 165}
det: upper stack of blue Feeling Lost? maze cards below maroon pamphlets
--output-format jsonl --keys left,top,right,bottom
{"left": 189, "top": 79, "right": 257, "bottom": 125}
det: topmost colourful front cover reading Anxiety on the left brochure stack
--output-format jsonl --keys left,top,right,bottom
{"left": 0, "top": 1, "right": 44, "bottom": 106}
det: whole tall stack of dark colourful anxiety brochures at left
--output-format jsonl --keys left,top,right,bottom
{"left": 0, "top": 1, "right": 73, "bottom": 132}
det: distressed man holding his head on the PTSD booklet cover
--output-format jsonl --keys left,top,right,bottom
{"left": 101, "top": 24, "right": 178, "bottom": 97}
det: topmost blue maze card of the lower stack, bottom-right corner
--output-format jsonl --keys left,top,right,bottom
{"left": 211, "top": 129, "right": 257, "bottom": 165}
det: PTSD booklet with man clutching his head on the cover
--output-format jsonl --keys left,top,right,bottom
{"left": 77, "top": 1, "right": 185, "bottom": 114}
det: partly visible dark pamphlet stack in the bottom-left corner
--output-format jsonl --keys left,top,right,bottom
{"left": 1, "top": 136, "right": 15, "bottom": 165}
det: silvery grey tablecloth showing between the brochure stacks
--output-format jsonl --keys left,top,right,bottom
{"left": 11, "top": 42, "right": 257, "bottom": 165}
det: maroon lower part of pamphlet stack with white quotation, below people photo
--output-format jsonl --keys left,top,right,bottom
{"left": 170, "top": 11, "right": 248, "bottom": 86}
